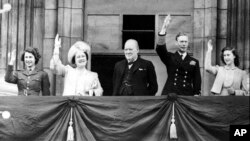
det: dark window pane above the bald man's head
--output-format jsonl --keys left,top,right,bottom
{"left": 122, "top": 15, "right": 155, "bottom": 50}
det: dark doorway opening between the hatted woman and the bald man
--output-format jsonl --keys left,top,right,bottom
{"left": 91, "top": 55, "right": 124, "bottom": 96}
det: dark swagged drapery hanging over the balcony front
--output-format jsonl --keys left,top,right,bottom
{"left": 0, "top": 96, "right": 249, "bottom": 141}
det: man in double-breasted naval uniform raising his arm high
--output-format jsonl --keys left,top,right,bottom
{"left": 156, "top": 15, "right": 201, "bottom": 96}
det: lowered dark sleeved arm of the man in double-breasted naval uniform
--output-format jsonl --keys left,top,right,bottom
{"left": 193, "top": 61, "right": 201, "bottom": 95}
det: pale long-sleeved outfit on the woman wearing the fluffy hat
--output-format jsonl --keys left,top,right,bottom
{"left": 50, "top": 59, "right": 103, "bottom": 96}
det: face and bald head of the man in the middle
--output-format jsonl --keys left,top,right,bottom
{"left": 124, "top": 40, "right": 139, "bottom": 61}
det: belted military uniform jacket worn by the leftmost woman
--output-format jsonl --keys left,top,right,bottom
{"left": 5, "top": 65, "right": 50, "bottom": 96}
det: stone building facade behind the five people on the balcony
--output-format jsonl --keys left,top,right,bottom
{"left": 0, "top": 0, "right": 250, "bottom": 96}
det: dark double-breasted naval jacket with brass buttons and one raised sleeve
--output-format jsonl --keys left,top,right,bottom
{"left": 156, "top": 44, "right": 201, "bottom": 95}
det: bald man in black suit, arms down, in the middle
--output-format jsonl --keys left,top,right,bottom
{"left": 113, "top": 39, "right": 158, "bottom": 96}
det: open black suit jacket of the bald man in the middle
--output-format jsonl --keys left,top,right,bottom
{"left": 113, "top": 57, "right": 158, "bottom": 96}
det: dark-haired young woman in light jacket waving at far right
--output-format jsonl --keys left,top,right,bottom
{"left": 205, "top": 40, "right": 245, "bottom": 96}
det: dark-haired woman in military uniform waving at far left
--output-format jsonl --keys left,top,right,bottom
{"left": 5, "top": 47, "right": 50, "bottom": 96}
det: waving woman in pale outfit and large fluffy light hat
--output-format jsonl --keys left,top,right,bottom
{"left": 50, "top": 35, "right": 103, "bottom": 96}
